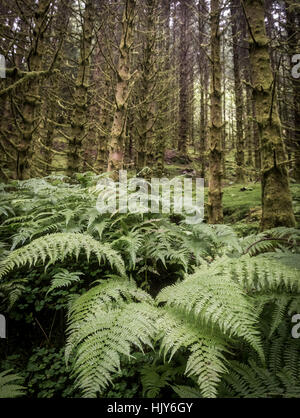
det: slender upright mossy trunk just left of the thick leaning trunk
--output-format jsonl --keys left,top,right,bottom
{"left": 208, "top": 0, "right": 223, "bottom": 224}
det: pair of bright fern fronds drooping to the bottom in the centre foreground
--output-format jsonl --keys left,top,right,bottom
{"left": 66, "top": 278, "right": 230, "bottom": 397}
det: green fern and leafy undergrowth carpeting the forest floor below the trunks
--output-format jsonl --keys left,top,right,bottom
{"left": 0, "top": 173, "right": 300, "bottom": 398}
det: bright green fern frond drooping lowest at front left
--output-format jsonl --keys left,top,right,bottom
{"left": 66, "top": 280, "right": 158, "bottom": 397}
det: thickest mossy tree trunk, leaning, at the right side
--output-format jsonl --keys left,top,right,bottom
{"left": 243, "top": 0, "right": 295, "bottom": 230}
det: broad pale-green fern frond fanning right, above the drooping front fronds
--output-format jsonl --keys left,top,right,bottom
{"left": 156, "top": 267, "right": 263, "bottom": 358}
